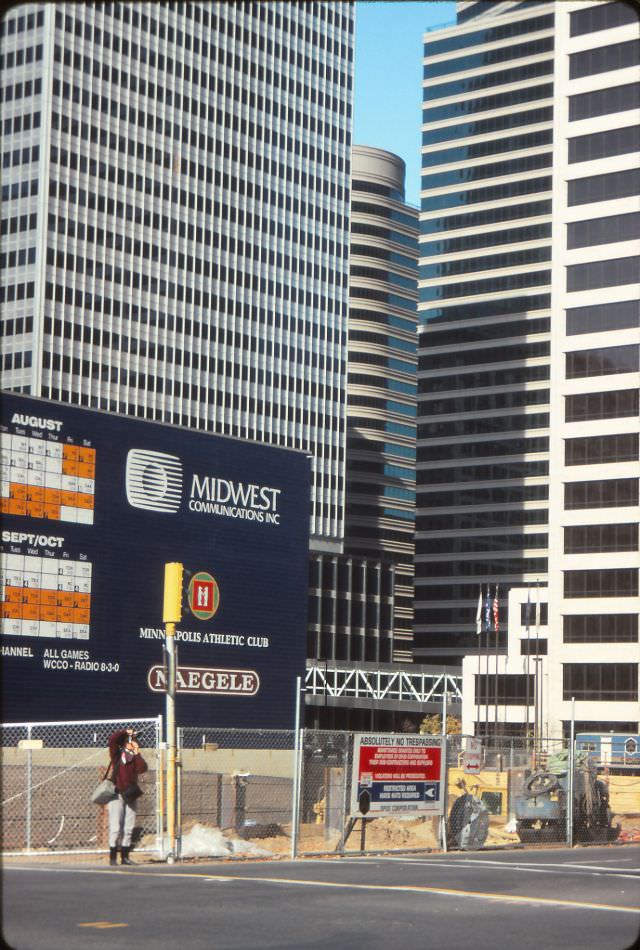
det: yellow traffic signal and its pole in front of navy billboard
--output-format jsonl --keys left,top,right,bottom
{"left": 162, "top": 562, "right": 183, "bottom": 864}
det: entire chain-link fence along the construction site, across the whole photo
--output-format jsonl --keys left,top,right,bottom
{"left": 5, "top": 719, "right": 640, "bottom": 858}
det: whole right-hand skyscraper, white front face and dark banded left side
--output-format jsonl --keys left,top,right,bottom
{"left": 416, "top": 2, "right": 640, "bottom": 734}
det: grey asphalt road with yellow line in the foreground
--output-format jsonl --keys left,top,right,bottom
{"left": 2, "top": 846, "right": 640, "bottom": 950}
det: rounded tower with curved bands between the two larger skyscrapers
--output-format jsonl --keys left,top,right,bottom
{"left": 345, "top": 145, "right": 418, "bottom": 661}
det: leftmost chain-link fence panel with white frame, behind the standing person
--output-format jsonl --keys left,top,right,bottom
{"left": 0, "top": 719, "right": 162, "bottom": 855}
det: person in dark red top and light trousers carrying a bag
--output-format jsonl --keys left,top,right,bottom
{"left": 109, "top": 729, "right": 148, "bottom": 865}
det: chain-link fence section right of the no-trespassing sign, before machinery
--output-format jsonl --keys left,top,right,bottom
{"left": 447, "top": 736, "right": 640, "bottom": 850}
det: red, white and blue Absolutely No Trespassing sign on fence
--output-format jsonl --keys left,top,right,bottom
{"left": 351, "top": 733, "right": 444, "bottom": 818}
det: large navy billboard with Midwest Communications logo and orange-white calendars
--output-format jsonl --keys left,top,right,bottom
{"left": 0, "top": 393, "right": 310, "bottom": 728}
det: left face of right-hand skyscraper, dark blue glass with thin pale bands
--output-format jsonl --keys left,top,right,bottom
{"left": 415, "top": 5, "right": 554, "bottom": 660}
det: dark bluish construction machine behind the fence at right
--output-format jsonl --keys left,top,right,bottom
{"left": 515, "top": 751, "right": 620, "bottom": 844}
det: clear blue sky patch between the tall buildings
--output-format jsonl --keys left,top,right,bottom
{"left": 353, "top": 0, "right": 456, "bottom": 205}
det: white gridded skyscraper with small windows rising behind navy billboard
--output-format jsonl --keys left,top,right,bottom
{"left": 0, "top": 2, "right": 353, "bottom": 551}
